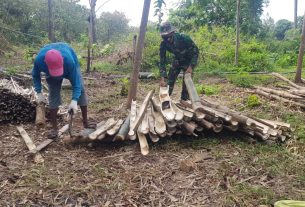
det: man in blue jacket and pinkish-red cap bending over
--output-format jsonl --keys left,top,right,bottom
{"left": 32, "top": 42, "right": 95, "bottom": 139}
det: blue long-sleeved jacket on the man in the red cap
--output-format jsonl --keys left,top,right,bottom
{"left": 32, "top": 42, "right": 82, "bottom": 101}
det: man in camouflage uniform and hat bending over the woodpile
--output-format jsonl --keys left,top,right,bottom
{"left": 160, "top": 22, "right": 199, "bottom": 100}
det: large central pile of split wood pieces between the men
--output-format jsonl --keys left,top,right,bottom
{"left": 66, "top": 75, "right": 292, "bottom": 155}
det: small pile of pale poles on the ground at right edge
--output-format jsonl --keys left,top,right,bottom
{"left": 255, "top": 73, "right": 305, "bottom": 109}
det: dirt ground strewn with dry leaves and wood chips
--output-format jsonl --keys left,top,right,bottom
{"left": 0, "top": 74, "right": 305, "bottom": 207}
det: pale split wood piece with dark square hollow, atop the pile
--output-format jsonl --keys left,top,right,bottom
{"left": 159, "top": 86, "right": 176, "bottom": 121}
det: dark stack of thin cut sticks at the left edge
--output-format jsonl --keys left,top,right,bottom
{"left": 0, "top": 78, "right": 35, "bottom": 124}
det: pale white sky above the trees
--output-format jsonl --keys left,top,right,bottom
{"left": 80, "top": 0, "right": 305, "bottom": 26}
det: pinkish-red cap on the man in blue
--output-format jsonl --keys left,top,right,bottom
{"left": 44, "top": 49, "right": 64, "bottom": 77}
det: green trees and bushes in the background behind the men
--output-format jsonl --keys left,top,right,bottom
{"left": 0, "top": 0, "right": 303, "bottom": 72}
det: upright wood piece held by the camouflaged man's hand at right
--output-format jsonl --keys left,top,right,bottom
{"left": 184, "top": 73, "right": 204, "bottom": 118}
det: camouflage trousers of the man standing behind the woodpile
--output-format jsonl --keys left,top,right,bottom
{"left": 167, "top": 61, "right": 189, "bottom": 100}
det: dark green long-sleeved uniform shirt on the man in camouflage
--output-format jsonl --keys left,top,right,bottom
{"left": 160, "top": 33, "right": 199, "bottom": 77}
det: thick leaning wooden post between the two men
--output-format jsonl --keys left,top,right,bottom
{"left": 127, "top": 0, "right": 151, "bottom": 108}
